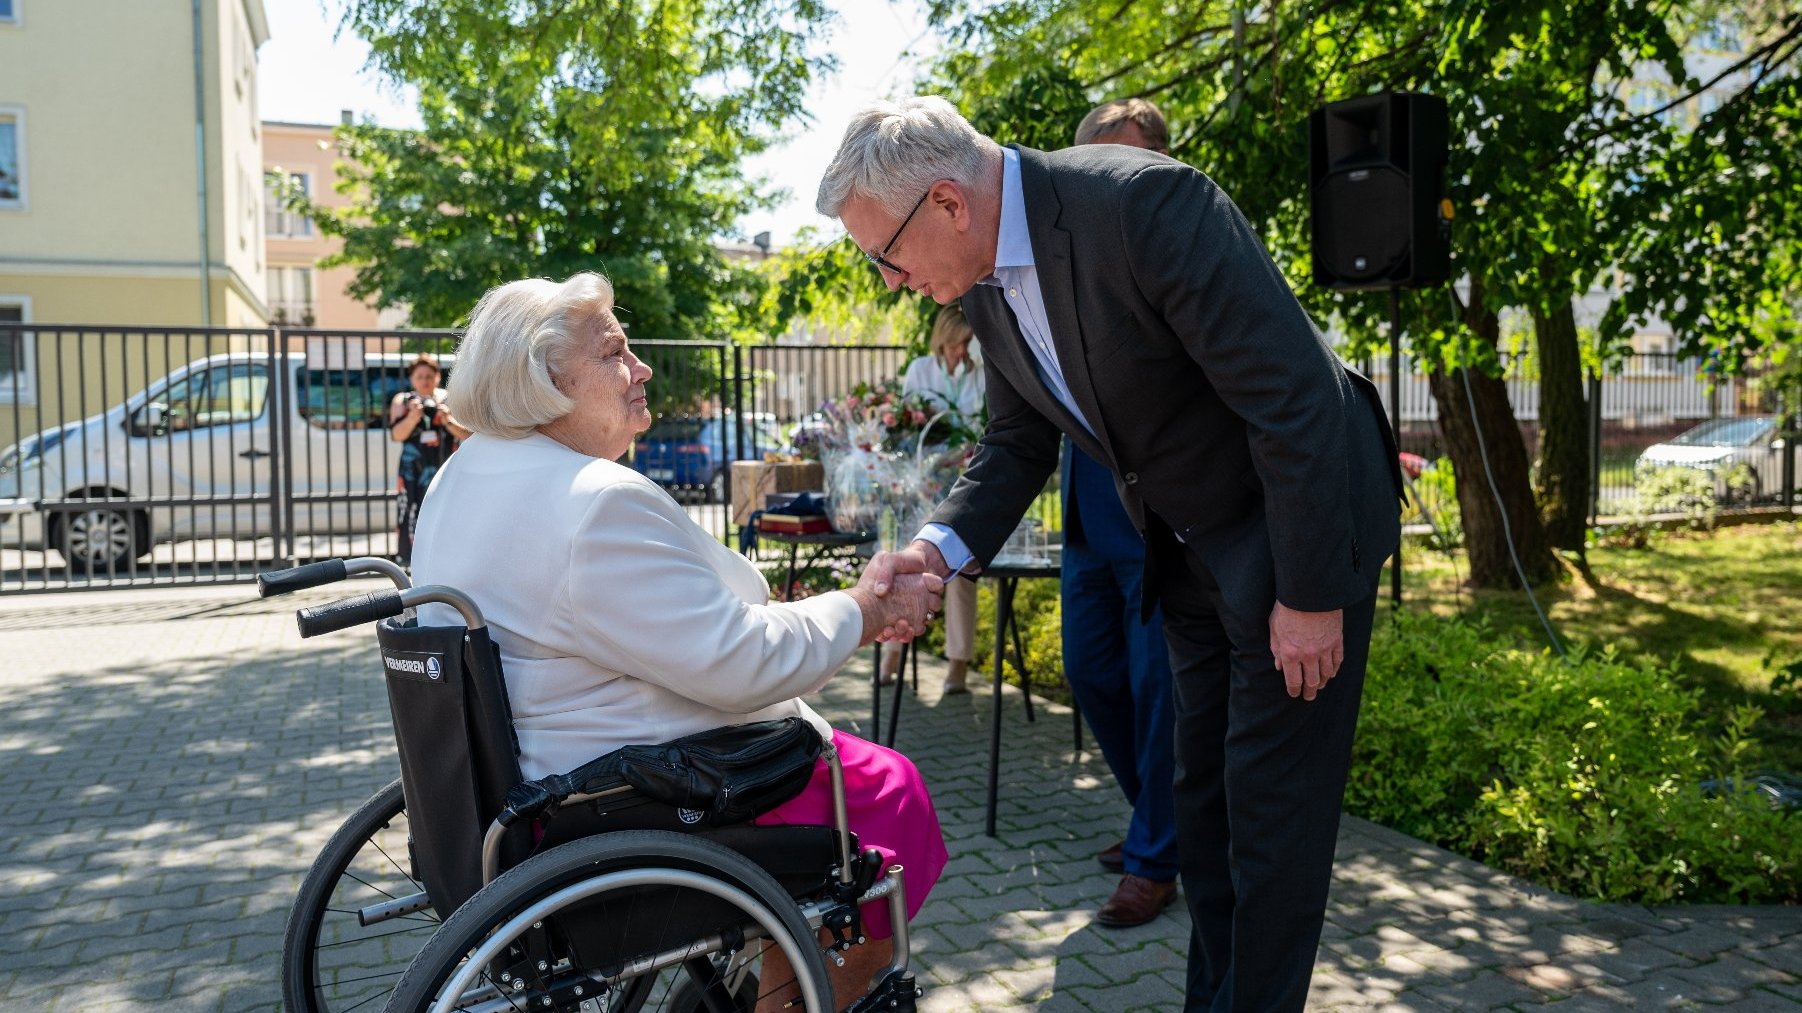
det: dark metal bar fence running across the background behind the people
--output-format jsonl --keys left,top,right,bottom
{"left": 0, "top": 324, "right": 1795, "bottom": 593}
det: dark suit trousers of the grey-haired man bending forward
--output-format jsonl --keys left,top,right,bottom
{"left": 1160, "top": 548, "right": 1377, "bottom": 1013}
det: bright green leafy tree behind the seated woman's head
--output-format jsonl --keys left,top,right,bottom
{"left": 305, "top": 0, "right": 829, "bottom": 346}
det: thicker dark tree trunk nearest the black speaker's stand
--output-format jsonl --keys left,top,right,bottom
{"left": 1427, "top": 296, "right": 1559, "bottom": 588}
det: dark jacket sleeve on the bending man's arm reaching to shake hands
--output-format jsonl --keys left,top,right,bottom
{"left": 930, "top": 310, "right": 1061, "bottom": 566}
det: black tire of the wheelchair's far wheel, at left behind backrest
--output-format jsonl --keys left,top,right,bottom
{"left": 281, "top": 779, "right": 434, "bottom": 1013}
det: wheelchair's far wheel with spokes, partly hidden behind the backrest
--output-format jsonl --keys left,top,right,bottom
{"left": 281, "top": 780, "right": 438, "bottom": 1013}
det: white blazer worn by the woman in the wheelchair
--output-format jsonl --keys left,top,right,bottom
{"left": 413, "top": 433, "right": 863, "bottom": 777}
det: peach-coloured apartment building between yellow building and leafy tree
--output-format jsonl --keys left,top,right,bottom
{"left": 263, "top": 112, "right": 387, "bottom": 330}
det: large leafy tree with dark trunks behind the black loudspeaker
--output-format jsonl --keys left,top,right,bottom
{"left": 915, "top": 0, "right": 1802, "bottom": 586}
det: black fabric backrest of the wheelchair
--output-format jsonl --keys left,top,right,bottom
{"left": 375, "top": 618, "right": 521, "bottom": 917}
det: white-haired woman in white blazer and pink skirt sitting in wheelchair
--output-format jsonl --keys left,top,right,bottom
{"left": 413, "top": 274, "right": 946, "bottom": 1008}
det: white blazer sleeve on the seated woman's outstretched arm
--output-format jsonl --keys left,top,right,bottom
{"left": 566, "top": 485, "right": 863, "bottom": 712}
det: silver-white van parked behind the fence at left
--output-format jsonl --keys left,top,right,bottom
{"left": 0, "top": 351, "right": 454, "bottom": 573}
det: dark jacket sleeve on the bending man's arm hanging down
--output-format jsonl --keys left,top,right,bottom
{"left": 1121, "top": 164, "right": 1370, "bottom": 611}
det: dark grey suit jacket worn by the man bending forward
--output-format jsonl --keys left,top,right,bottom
{"left": 932, "top": 144, "right": 1400, "bottom": 615}
